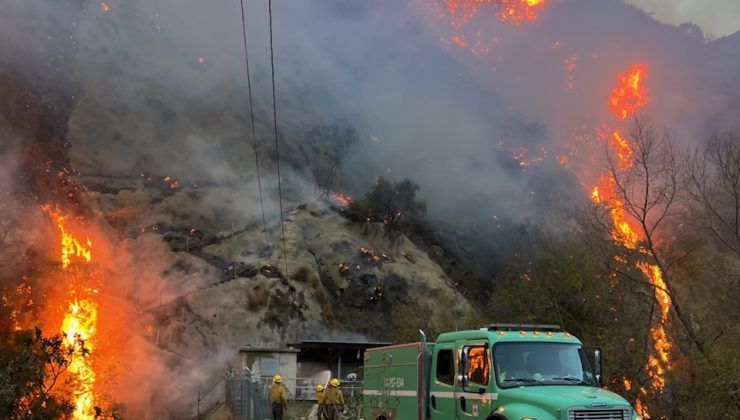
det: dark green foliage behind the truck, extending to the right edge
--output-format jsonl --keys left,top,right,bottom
{"left": 486, "top": 228, "right": 740, "bottom": 419}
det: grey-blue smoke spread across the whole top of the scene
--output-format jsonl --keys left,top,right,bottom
{"left": 2, "top": 0, "right": 739, "bottom": 231}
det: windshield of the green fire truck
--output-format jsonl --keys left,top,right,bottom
{"left": 493, "top": 343, "right": 598, "bottom": 388}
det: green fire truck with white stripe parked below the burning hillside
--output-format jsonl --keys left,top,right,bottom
{"left": 363, "top": 324, "right": 640, "bottom": 420}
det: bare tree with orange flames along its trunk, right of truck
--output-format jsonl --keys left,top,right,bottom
{"left": 592, "top": 116, "right": 737, "bottom": 410}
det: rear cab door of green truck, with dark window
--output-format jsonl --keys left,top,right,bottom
{"left": 428, "top": 343, "right": 457, "bottom": 420}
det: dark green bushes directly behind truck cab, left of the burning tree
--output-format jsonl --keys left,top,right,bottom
{"left": 490, "top": 234, "right": 651, "bottom": 406}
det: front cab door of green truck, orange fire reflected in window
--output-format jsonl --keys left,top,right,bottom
{"left": 454, "top": 340, "right": 492, "bottom": 419}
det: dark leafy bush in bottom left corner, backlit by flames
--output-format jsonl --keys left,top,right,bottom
{"left": 0, "top": 328, "right": 76, "bottom": 419}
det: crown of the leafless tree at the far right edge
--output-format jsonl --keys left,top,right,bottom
{"left": 686, "top": 132, "right": 740, "bottom": 256}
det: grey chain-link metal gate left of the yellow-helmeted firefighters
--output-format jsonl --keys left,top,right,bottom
{"left": 226, "top": 376, "right": 271, "bottom": 420}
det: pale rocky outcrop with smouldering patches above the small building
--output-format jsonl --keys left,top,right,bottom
{"left": 128, "top": 202, "right": 473, "bottom": 353}
